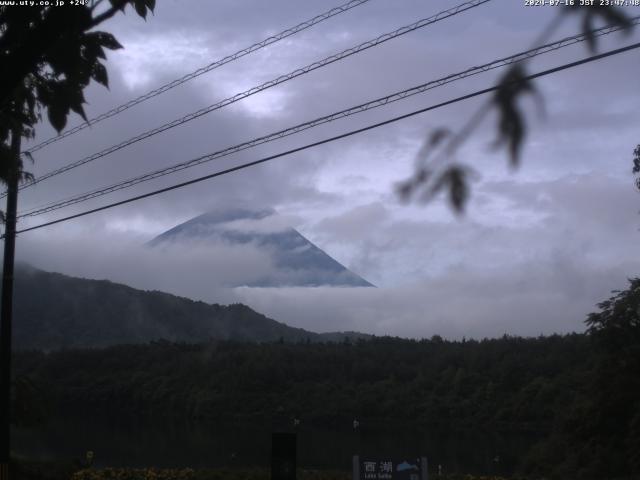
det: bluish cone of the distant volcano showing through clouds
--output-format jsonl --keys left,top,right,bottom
{"left": 147, "top": 208, "right": 373, "bottom": 287}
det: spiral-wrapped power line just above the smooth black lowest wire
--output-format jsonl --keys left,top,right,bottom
{"left": 18, "top": 16, "right": 640, "bottom": 218}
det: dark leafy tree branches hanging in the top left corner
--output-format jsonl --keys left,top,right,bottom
{"left": 0, "top": 0, "right": 155, "bottom": 192}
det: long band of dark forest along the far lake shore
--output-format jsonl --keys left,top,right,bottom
{"left": 15, "top": 335, "right": 593, "bottom": 431}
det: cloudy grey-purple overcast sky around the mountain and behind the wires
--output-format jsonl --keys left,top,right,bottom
{"left": 17, "top": 0, "right": 640, "bottom": 338}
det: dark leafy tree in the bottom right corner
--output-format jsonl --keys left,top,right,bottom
{"left": 530, "top": 278, "right": 640, "bottom": 478}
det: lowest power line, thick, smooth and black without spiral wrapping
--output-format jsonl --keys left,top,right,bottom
{"left": 10, "top": 43, "right": 640, "bottom": 238}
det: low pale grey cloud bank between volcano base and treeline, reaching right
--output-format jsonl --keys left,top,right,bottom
{"left": 230, "top": 255, "right": 627, "bottom": 339}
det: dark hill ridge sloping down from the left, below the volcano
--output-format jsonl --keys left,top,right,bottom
{"left": 13, "top": 265, "right": 370, "bottom": 350}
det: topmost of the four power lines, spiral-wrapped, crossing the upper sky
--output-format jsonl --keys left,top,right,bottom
{"left": 25, "top": 0, "right": 376, "bottom": 153}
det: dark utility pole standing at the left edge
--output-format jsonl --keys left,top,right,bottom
{"left": 0, "top": 128, "right": 21, "bottom": 480}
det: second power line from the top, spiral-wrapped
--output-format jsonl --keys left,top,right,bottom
{"left": 8, "top": 0, "right": 491, "bottom": 196}
